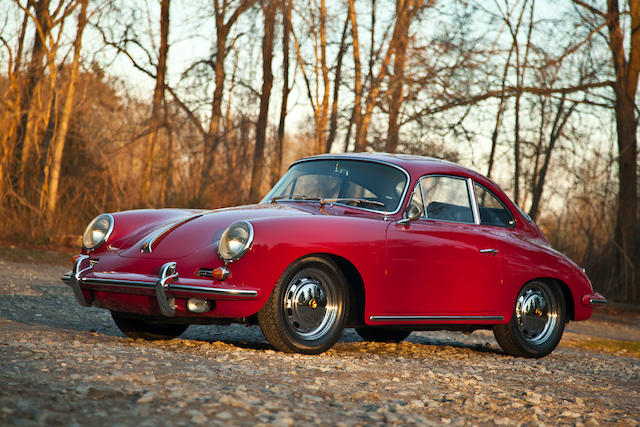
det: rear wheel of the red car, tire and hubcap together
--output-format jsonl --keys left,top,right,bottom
{"left": 493, "top": 280, "right": 567, "bottom": 357}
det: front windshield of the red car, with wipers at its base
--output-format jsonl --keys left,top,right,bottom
{"left": 262, "top": 159, "right": 407, "bottom": 213}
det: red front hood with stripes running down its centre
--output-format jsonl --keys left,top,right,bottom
{"left": 116, "top": 204, "right": 312, "bottom": 260}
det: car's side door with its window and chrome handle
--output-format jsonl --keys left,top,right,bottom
{"left": 380, "top": 175, "right": 502, "bottom": 322}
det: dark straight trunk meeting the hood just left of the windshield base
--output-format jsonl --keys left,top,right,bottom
{"left": 249, "top": 0, "right": 277, "bottom": 203}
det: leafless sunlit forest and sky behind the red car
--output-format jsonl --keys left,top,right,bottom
{"left": 0, "top": 0, "right": 640, "bottom": 302}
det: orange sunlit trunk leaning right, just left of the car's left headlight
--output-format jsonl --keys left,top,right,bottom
{"left": 45, "top": 0, "right": 89, "bottom": 221}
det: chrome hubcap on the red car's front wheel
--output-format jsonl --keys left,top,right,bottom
{"left": 283, "top": 275, "right": 337, "bottom": 340}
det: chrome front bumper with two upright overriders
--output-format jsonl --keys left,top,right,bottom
{"left": 62, "top": 255, "right": 258, "bottom": 317}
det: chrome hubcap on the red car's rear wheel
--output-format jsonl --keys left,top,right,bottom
{"left": 516, "top": 284, "right": 559, "bottom": 345}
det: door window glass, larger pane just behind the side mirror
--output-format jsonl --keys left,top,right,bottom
{"left": 420, "top": 176, "right": 473, "bottom": 223}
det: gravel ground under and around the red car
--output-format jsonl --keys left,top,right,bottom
{"left": 0, "top": 260, "right": 640, "bottom": 426}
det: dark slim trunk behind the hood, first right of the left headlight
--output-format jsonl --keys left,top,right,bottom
{"left": 140, "top": 0, "right": 170, "bottom": 206}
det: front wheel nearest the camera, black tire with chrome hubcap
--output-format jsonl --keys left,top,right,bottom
{"left": 258, "top": 257, "right": 349, "bottom": 354}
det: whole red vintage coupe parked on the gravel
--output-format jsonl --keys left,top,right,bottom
{"left": 63, "top": 154, "right": 606, "bottom": 357}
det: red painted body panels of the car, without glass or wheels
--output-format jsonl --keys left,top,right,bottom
{"left": 69, "top": 154, "right": 599, "bottom": 327}
